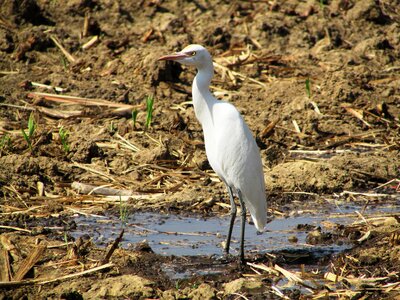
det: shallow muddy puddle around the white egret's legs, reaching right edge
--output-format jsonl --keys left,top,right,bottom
{"left": 73, "top": 201, "right": 400, "bottom": 257}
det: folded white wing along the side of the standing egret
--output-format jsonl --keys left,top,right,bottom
{"left": 213, "top": 102, "right": 266, "bottom": 231}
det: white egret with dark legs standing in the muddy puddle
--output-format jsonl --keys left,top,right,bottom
{"left": 158, "top": 44, "right": 267, "bottom": 265}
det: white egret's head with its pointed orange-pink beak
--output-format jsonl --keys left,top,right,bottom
{"left": 158, "top": 45, "right": 212, "bottom": 69}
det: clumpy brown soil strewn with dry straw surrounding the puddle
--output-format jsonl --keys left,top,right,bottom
{"left": 0, "top": 0, "right": 400, "bottom": 299}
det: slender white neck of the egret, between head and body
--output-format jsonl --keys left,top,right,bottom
{"left": 192, "top": 62, "right": 217, "bottom": 125}
